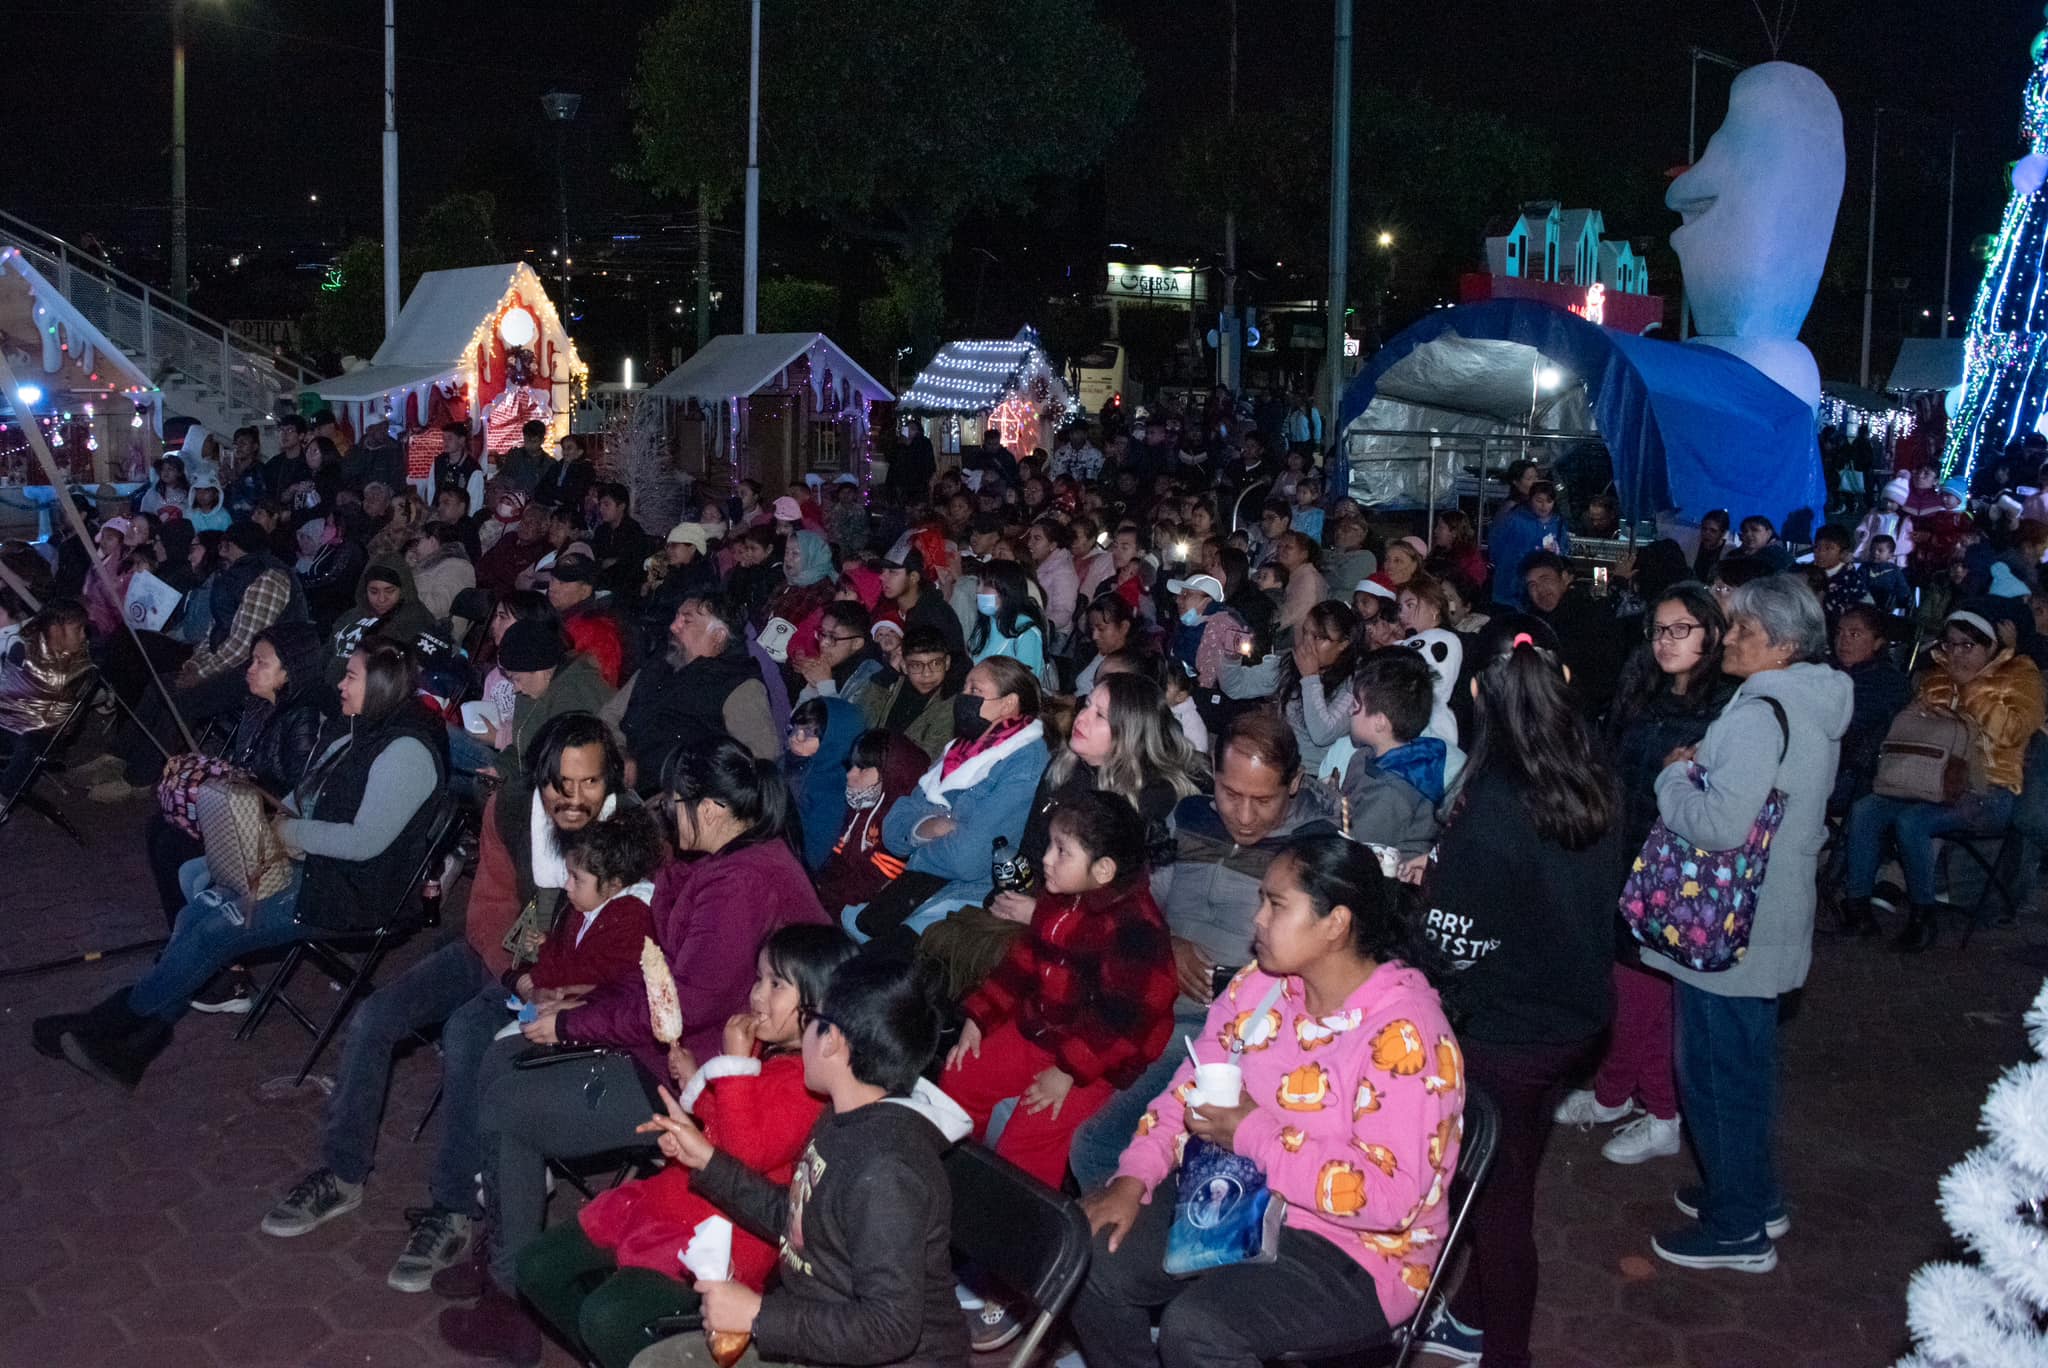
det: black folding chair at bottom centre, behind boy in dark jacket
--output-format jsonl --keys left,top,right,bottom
{"left": 946, "top": 1145, "right": 1092, "bottom": 1368}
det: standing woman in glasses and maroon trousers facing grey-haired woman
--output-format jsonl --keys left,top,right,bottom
{"left": 1556, "top": 582, "right": 1735, "bottom": 1163}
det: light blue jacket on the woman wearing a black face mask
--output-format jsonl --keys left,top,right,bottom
{"left": 883, "top": 723, "right": 1051, "bottom": 932}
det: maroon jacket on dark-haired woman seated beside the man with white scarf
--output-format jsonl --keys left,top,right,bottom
{"left": 555, "top": 842, "right": 831, "bottom": 1079}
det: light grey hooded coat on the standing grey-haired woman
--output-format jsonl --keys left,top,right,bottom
{"left": 1642, "top": 664, "right": 1855, "bottom": 997}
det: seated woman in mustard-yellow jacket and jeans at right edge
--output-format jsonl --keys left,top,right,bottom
{"left": 1841, "top": 610, "right": 2048, "bottom": 954}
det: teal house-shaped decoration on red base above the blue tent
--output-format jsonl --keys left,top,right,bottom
{"left": 1458, "top": 201, "right": 1663, "bottom": 332}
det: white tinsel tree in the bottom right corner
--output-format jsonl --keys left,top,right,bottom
{"left": 1898, "top": 983, "right": 2048, "bottom": 1368}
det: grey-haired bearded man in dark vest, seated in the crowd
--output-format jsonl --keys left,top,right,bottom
{"left": 604, "top": 594, "right": 782, "bottom": 793}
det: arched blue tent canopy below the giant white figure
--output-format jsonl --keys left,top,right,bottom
{"left": 1333, "top": 299, "right": 1827, "bottom": 528}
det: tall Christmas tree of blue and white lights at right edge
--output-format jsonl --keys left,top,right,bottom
{"left": 1942, "top": 31, "right": 2048, "bottom": 479}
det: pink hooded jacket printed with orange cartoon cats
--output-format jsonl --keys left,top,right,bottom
{"left": 1116, "top": 965, "right": 1464, "bottom": 1325}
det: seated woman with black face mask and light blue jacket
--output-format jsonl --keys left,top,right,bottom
{"left": 860, "top": 655, "right": 1049, "bottom": 940}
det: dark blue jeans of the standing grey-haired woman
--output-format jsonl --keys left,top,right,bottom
{"left": 1677, "top": 983, "right": 1784, "bottom": 1241}
